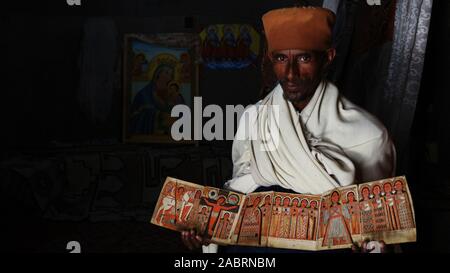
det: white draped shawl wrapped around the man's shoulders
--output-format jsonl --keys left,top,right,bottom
{"left": 225, "top": 82, "right": 395, "bottom": 194}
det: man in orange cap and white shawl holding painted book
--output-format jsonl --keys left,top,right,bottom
{"left": 182, "top": 8, "right": 395, "bottom": 252}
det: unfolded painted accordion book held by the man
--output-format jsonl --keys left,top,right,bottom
{"left": 151, "top": 176, "right": 416, "bottom": 250}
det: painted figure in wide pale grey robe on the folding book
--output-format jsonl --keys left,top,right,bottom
{"left": 322, "top": 191, "right": 352, "bottom": 247}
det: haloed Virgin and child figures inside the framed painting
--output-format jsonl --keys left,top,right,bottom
{"left": 129, "top": 48, "right": 190, "bottom": 135}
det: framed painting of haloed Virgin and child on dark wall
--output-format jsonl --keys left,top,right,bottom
{"left": 123, "top": 33, "right": 199, "bottom": 143}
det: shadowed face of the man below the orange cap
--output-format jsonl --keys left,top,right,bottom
{"left": 270, "top": 49, "right": 327, "bottom": 103}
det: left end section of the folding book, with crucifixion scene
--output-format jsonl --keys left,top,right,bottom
{"left": 151, "top": 177, "right": 246, "bottom": 244}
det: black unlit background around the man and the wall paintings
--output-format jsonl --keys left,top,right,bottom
{"left": 0, "top": 0, "right": 450, "bottom": 252}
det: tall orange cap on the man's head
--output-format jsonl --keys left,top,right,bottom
{"left": 262, "top": 7, "right": 336, "bottom": 53}
